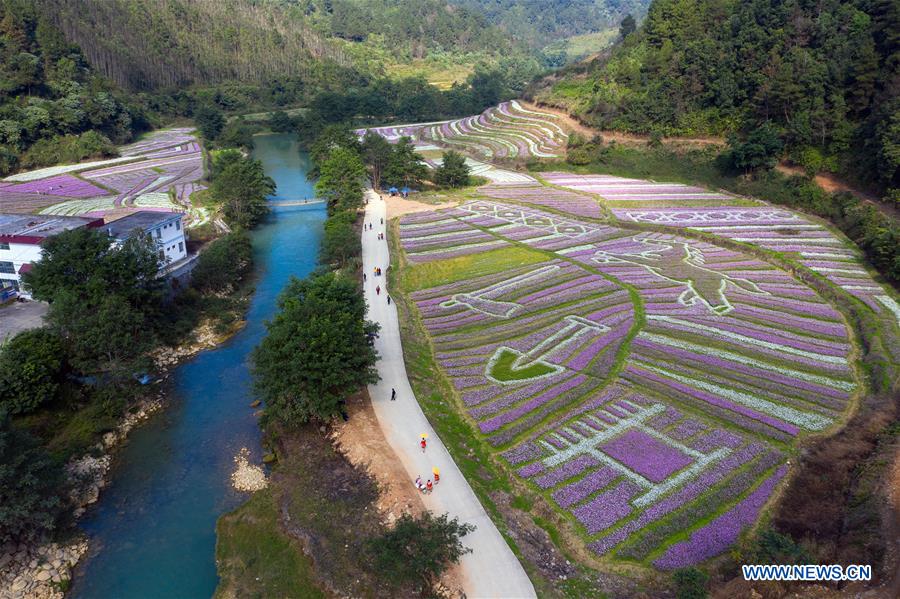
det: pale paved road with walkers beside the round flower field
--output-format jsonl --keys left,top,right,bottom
{"left": 362, "top": 191, "right": 535, "bottom": 599}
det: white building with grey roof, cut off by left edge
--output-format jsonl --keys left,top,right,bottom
{"left": 0, "top": 214, "right": 103, "bottom": 297}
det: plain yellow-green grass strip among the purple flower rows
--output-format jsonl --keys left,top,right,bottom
{"left": 400, "top": 247, "right": 547, "bottom": 292}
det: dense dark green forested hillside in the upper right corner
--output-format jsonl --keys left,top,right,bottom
{"left": 534, "top": 0, "right": 900, "bottom": 191}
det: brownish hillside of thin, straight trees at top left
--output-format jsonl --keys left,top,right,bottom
{"left": 33, "top": 0, "right": 358, "bottom": 90}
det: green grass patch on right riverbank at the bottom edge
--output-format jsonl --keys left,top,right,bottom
{"left": 215, "top": 490, "right": 326, "bottom": 599}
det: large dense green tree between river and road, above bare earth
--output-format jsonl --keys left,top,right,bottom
{"left": 252, "top": 272, "right": 378, "bottom": 424}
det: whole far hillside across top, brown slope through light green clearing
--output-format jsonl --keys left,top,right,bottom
{"left": 31, "top": 0, "right": 541, "bottom": 90}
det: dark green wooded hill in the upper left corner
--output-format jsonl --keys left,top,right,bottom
{"left": 0, "top": 0, "right": 149, "bottom": 176}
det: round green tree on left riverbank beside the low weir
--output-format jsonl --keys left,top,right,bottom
{"left": 210, "top": 158, "right": 275, "bottom": 229}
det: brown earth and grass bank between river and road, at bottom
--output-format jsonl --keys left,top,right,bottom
{"left": 215, "top": 391, "right": 472, "bottom": 598}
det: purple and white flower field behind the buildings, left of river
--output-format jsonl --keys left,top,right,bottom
{"left": 0, "top": 129, "right": 203, "bottom": 227}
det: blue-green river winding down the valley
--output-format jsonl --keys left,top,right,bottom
{"left": 70, "top": 134, "right": 325, "bottom": 599}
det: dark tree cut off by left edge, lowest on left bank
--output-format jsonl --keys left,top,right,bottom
{"left": 0, "top": 410, "right": 64, "bottom": 543}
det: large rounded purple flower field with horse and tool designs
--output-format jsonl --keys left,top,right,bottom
{"left": 399, "top": 191, "right": 890, "bottom": 570}
